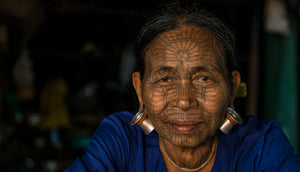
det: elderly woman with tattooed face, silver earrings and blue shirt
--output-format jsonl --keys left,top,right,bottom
{"left": 66, "top": 3, "right": 300, "bottom": 172}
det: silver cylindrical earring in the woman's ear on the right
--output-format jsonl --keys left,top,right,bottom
{"left": 219, "top": 107, "right": 243, "bottom": 134}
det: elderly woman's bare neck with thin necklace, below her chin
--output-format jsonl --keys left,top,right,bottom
{"left": 159, "top": 136, "right": 218, "bottom": 172}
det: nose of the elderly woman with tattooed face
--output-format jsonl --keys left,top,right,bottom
{"left": 176, "top": 81, "right": 197, "bottom": 110}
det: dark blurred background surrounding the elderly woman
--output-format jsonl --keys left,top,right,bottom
{"left": 0, "top": 0, "right": 300, "bottom": 172}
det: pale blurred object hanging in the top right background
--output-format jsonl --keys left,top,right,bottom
{"left": 264, "top": 0, "right": 290, "bottom": 35}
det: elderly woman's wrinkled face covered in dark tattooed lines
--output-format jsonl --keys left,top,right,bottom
{"left": 142, "top": 26, "right": 230, "bottom": 147}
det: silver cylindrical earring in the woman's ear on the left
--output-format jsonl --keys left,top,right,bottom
{"left": 130, "top": 108, "right": 154, "bottom": 135}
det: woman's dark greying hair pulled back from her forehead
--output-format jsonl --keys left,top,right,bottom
{"left": 135, "top": 4, "right": 237, "bottom": 77}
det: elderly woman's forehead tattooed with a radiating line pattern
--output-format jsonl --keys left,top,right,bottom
{"left": 145, "top": 26, "right": 224, "bottom": 68}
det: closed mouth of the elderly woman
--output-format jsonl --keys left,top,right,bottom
{"left": 168, "top": 121, "right": 201, "bottom": 134}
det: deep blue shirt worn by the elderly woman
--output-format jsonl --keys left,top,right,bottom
{"left": 65, "top": 111, "right": 300, "bottom": 172}
